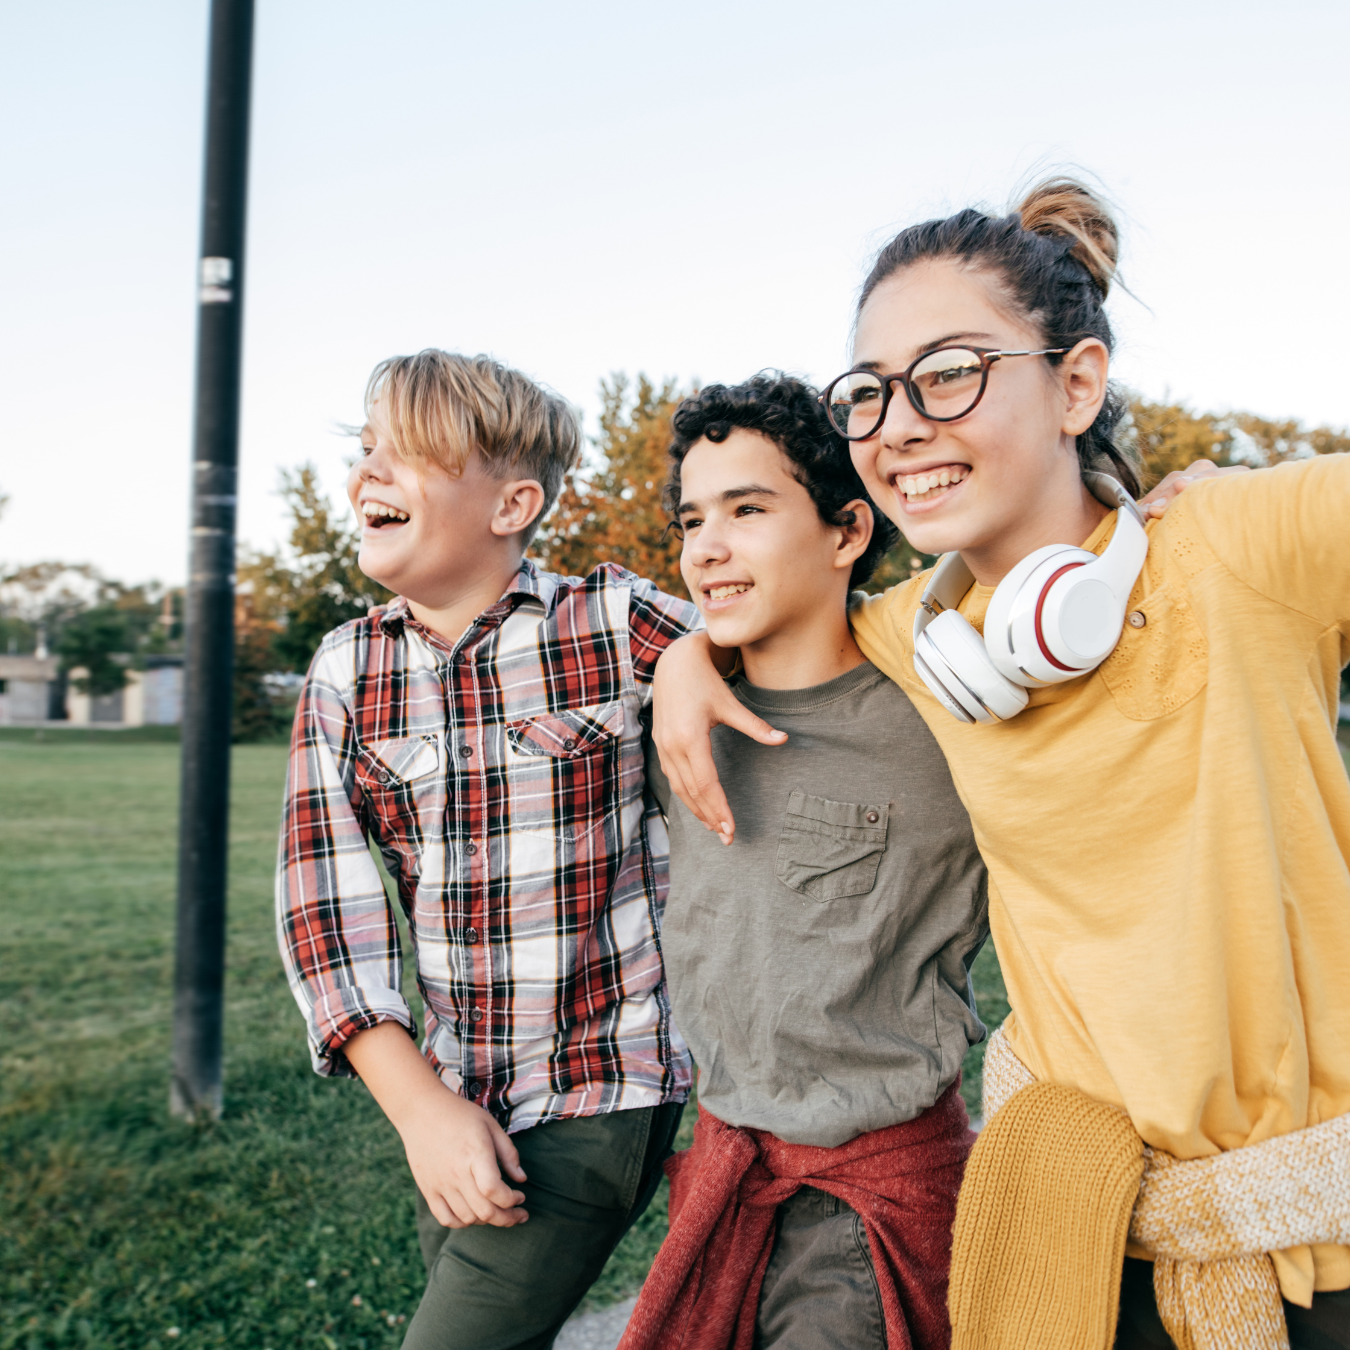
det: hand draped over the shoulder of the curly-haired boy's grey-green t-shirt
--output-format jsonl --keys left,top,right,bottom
{"left": 652, "top": 633, "right": 787, "bottom": 844}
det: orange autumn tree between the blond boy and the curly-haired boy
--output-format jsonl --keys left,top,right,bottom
{"left": 533, "top": 374, "right": 684, "bottom": 595}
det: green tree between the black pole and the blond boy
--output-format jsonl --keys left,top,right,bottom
{"left": 236, "top": 464, "right": 393, "bottom": 671}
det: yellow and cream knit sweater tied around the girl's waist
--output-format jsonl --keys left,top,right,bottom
{"left": 949, "top": 1029, "right": 1350, "bottom": 1350}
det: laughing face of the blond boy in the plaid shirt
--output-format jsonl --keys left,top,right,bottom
{"left": 347, "top": 400, "right": 515, "bottom": 608}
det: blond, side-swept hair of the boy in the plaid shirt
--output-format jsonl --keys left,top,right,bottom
{"left": 366, "top": 347, "right": 582, "bottom": 545}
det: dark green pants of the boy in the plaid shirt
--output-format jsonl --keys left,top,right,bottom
{"left": 404, "top": 1103, "right": 683, "bottom": 1350}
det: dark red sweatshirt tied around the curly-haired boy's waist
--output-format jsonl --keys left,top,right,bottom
{"left": 618, "top": 1083, "right": 975, "bottom": 1350}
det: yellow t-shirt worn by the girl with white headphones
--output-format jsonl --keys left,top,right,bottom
{"left": 853, "top": 455, "right": 1350, "bottom": 1305}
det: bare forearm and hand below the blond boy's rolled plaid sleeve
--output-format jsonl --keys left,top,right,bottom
{"left": 343, "top": 1022, "right": 529, "bottom": 1229}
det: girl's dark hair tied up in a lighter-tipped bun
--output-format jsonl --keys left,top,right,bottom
{"left": 857, "top": 177, "right": 1142, "bottom": 497}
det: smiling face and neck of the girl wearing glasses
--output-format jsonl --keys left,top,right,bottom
{"left": 852, "top": 259, "right": 1107, "bottom": 582}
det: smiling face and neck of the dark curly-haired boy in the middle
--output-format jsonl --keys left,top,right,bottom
{"left": 676, "top": 428, "right": 871, "bottom": 687}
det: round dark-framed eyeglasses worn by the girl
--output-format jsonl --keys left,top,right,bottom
{"left": 821, "top": 347, "right": 1069, "bottom": 440}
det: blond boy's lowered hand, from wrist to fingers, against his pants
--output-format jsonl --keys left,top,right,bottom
{"left": 398, "top": 1085, "right": 529, "bottom": 1229}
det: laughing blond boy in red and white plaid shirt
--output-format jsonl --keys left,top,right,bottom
{"left": 277, "top": 351, "right": 697, "bottom": 1350}
